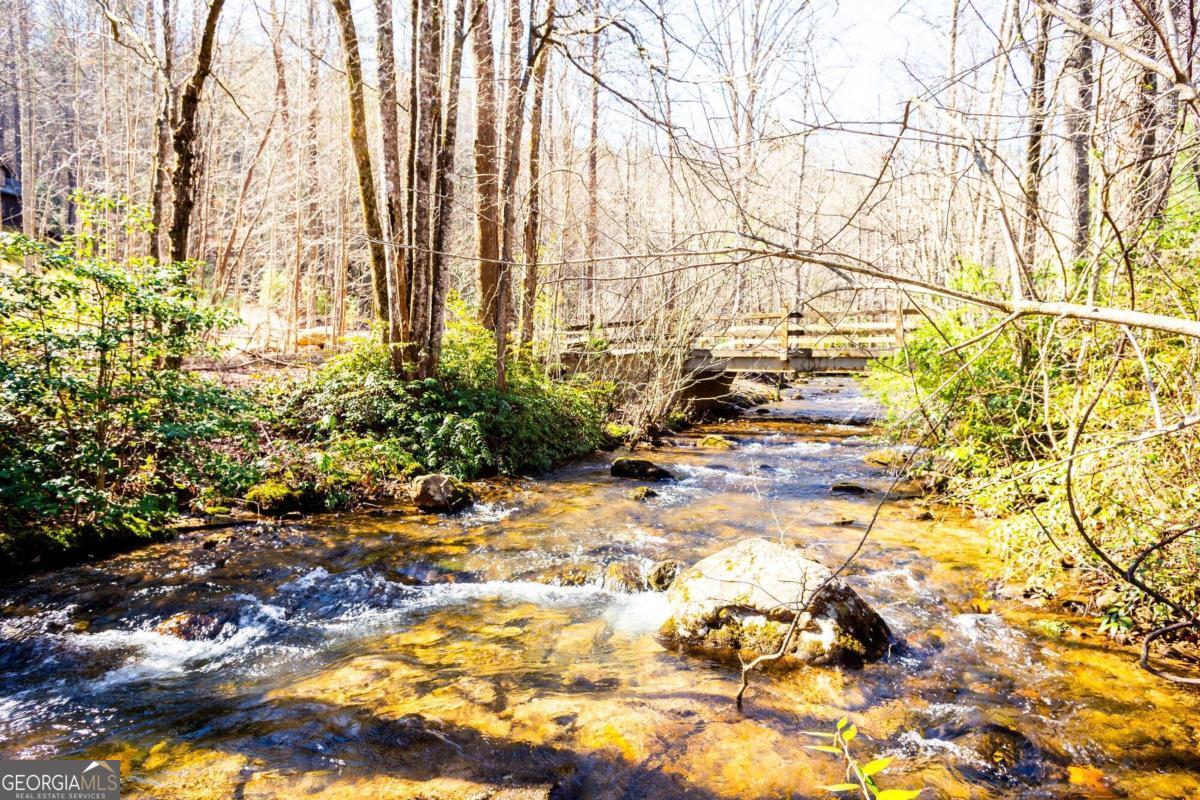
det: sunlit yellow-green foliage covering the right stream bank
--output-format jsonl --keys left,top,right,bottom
{"left": 868, "top": 212, "right": 1200, "bottom": 640}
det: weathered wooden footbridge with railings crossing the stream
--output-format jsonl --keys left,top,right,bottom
{"left": 564, "top": 307, "right": 920, "bottom": 375}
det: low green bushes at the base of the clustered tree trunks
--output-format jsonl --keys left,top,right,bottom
{"left": 274, "top": 293, "right": 610, "bottom": 479}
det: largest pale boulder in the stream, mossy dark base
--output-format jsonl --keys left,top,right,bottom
{"left": 659, "top": 539, "right": 892, "bottom": 667}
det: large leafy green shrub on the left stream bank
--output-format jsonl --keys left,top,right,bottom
{"left": 0, "top": 198, "right": 250, "bottom": 561}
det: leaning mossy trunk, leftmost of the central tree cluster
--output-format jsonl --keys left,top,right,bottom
{"left": 332, "top": 0, "right": 390, "bottom": 344}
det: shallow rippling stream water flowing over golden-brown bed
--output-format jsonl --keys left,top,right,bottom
{"left": 0, "top": 379, "right": 1200, "bottom": 799}
